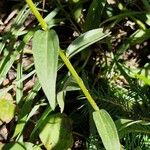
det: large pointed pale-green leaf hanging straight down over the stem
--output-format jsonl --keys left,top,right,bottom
{"left": 33, "top": 30, "right": 59, "bottom": 110}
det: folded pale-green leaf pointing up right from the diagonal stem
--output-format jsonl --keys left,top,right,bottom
{"left": 66, "top": 28, "right": 110, "bottom": 58}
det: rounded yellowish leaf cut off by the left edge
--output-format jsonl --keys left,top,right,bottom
{"left": 0, "top": 98, "right": 15, "bottom": 125}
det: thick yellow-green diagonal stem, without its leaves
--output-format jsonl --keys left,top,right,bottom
{"left": 26, "top": 0, "right": 99, "bottom": 111}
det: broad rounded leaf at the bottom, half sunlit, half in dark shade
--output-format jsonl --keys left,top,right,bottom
{"left": 40, "top": 113, "right": 73, "bottom": 150}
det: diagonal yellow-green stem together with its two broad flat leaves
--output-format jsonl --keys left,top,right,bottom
{"left": 26, "top": 0, "right": 120, "bottom": 150}
